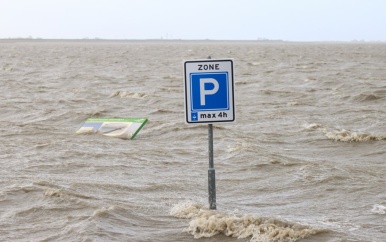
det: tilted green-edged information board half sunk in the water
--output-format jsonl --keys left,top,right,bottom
{"left": 76, "top": 118, "right": 147, "bottom": 139}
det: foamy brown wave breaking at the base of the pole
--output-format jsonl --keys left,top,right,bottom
{"left": 170, "top": 201, "right": 325, "bottom": 242}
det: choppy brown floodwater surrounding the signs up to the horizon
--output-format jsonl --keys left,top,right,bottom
{"left": 0, "top": 40, "right": 386, "bottom": 242}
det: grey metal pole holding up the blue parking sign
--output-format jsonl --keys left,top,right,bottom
{"left": 208, "top": 124, "right": 216, "bottom": 209}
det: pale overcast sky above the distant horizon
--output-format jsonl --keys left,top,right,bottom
{"left": 0, "top": 0, "right": 386, "bottom": 41}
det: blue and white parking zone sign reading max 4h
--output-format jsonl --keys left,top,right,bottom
{"left": 184, "top": 59, "right": 235, "bottom": 123}
